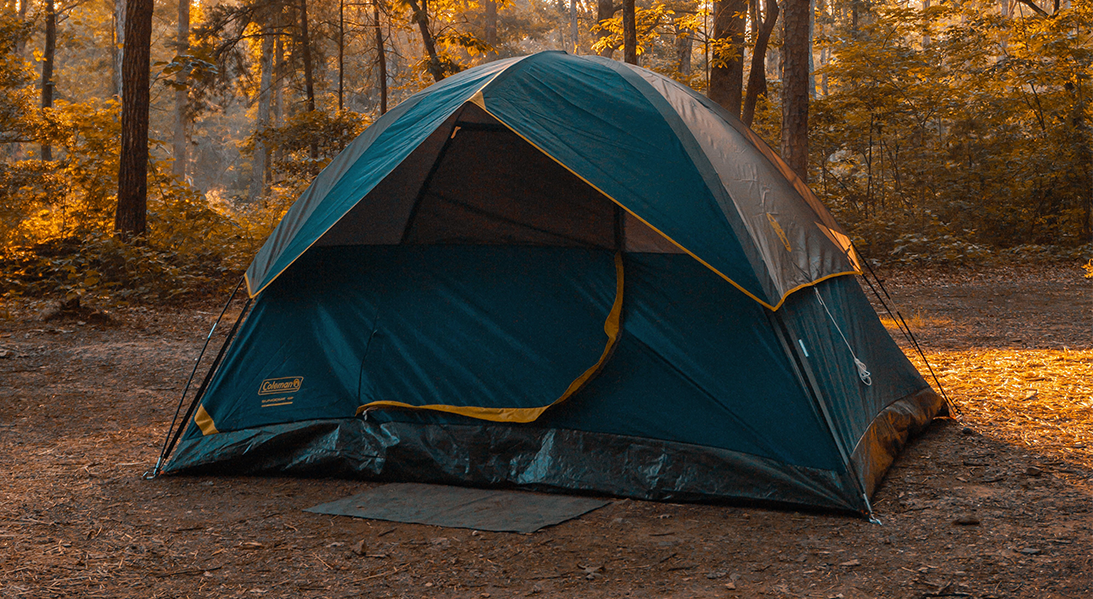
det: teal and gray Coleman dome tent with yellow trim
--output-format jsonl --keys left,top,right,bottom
{"left": 159, "top": 52, "right": 943, "bottom": 513}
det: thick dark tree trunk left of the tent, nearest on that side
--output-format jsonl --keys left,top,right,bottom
{"left": 114, "top": 0, "right": 153, "bottom": 243}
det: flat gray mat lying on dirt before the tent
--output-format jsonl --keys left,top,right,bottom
{"left": 304, "top": 483, "right": 611, "bottom": 532}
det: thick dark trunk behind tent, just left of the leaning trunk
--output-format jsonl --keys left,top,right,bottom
{"left": 709, "top": 0, "right": 748, "bottom": 117}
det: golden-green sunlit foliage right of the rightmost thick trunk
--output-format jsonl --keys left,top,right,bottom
{"left": 812, "top": 1, "right": 1093, "bottom": 260}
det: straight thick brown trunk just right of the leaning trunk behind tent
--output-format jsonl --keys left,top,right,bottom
{"left": 781, "top": 0, "right": 812, "bottom": 181}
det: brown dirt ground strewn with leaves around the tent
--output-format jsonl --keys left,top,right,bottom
{"left": 0, "top": 265, "right": 1093, "bottom": 599}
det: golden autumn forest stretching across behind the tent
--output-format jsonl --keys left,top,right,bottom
{"left": 0, "top": 0, "right": 1093, "bottom": 303}
